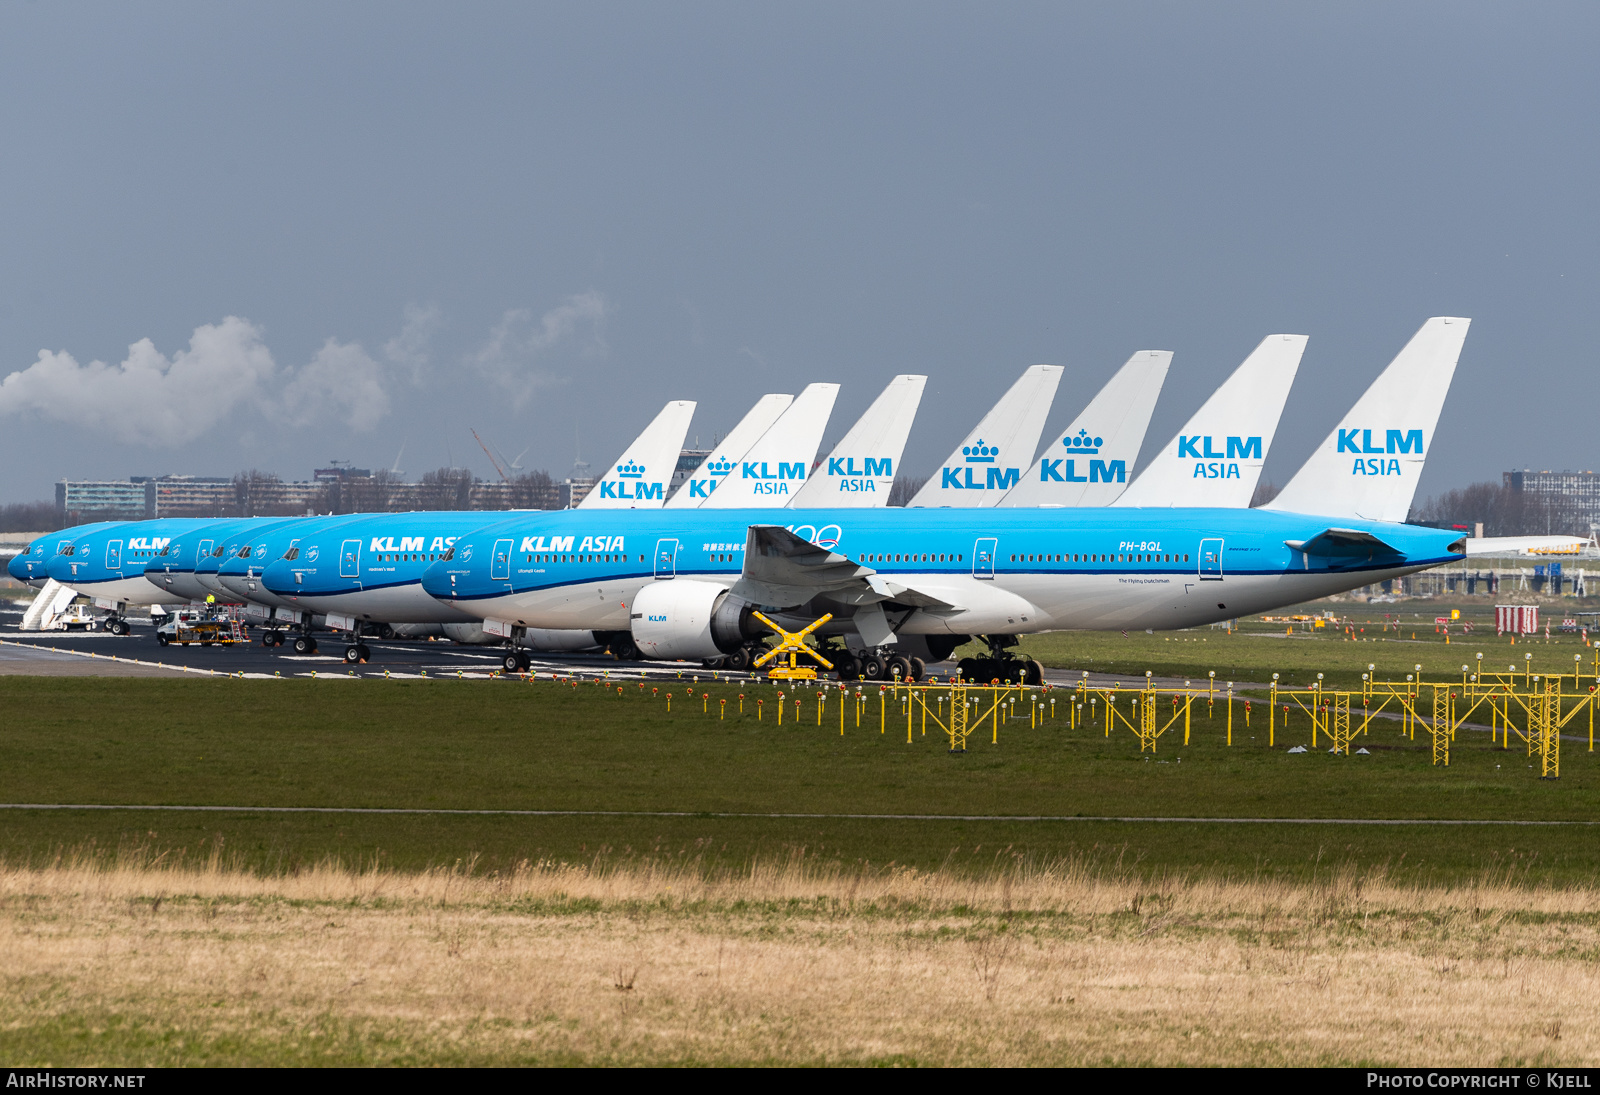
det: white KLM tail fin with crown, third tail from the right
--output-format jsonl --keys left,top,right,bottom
{"left": 1000, "top": 351, "right": 1173, "bottom": 506}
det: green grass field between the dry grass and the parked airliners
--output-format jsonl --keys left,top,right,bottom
{"left": 0, "top": 662, "right": 1600, "bottom": 880}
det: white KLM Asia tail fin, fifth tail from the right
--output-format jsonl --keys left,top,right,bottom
{"left": 789, "top": 375, "right": 928, "bottom": 509}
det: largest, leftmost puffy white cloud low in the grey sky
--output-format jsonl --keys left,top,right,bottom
{"left": 0, "top": 315, "right": 277, "bottom": 448}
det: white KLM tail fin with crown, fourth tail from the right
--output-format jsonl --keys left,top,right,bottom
{"left": 910, "top": 365, "right": 1061, "bottom": 509}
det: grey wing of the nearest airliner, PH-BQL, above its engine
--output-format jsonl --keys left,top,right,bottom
{"left": 733, "top": 525, "right": 955, "bottom": 608}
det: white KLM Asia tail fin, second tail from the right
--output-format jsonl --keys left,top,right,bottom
{"left": 1112, "top": 335, "right": 1307, "bottom": 509}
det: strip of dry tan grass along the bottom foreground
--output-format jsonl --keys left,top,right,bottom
{"left": 0, "top": 855, "right": 1600, "bottom": 1066}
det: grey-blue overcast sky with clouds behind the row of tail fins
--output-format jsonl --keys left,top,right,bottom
{"left": 0, "top": 2, "right": 1600, "bottom": 501}
